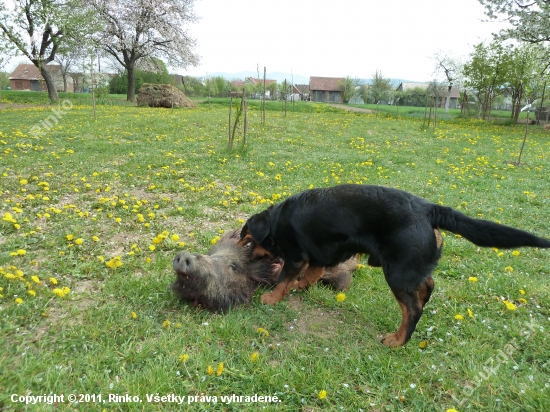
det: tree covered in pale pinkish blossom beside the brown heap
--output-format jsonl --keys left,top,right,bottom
{"left": 90, "top": 0, "right": 199, "bottom": 101}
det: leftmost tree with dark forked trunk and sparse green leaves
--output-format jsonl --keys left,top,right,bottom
{"left": 0, "top": 0, "right": 94, "bottom": 101}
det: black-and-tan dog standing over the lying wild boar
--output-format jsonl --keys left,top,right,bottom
{"left": 241, "top": 185, "right": 550, "bottom": 347}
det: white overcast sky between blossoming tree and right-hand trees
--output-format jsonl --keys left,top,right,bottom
{"left": 182, "top": 0, "right": 503, "bottom": 81}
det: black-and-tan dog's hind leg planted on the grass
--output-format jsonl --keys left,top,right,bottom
{"left": 382, "top": 275, "right": 434, "bottom": 348}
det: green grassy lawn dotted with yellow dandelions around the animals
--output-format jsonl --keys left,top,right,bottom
{"left": 0, "top": 98, "right": 550, "bottom": 411}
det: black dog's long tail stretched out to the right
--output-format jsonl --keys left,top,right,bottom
{"left": 428, "top": 204, "right": 550, "bottom": 249}
